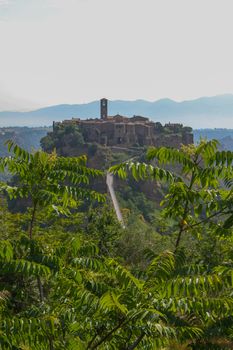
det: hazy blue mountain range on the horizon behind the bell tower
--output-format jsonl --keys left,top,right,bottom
{"left": 0, "top": 94, "right": 233, "bottom": 128}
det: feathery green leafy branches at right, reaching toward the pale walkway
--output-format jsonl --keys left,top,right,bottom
{"left": 110, "top": 140, "right": 233, "bottom": 247}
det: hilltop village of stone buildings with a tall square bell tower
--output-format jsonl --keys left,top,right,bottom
{"left": 53, "top": 98, "right": 193, "bottom": 148}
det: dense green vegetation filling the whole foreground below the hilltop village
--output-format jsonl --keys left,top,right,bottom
{"left": 0, "top": 141, "right": 233, "bottom": 350}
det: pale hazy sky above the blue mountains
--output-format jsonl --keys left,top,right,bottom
{"left": 0, "top": 0, "right": 233, "bottom": 106}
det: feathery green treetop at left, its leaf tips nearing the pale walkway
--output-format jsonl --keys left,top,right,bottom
{"left": 0, "top": 141, "right": 104, "bottom": 234}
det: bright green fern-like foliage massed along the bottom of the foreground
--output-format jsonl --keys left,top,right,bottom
{"left": 1, "top": 235, "right": 232, "bottom": 349}
